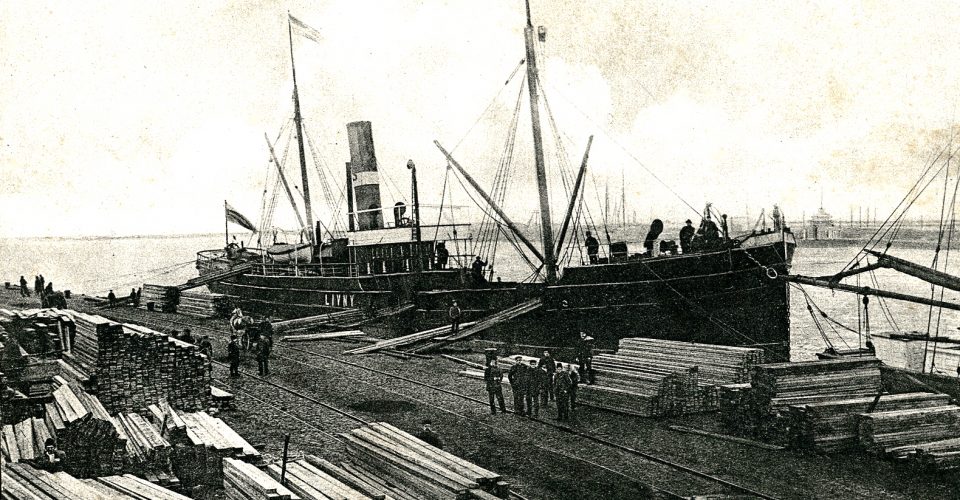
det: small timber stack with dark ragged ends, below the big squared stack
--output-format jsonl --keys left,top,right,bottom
{"left": 45, "top": 377, "right": 127, "bottom": 478}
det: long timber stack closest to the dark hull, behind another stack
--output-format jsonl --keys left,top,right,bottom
{"left": 616, "top": 338, "right": 763, "bottom": 385}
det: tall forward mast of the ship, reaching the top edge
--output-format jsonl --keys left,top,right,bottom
{"left": 523, "top": 0, "right": 557, "bottom": 283}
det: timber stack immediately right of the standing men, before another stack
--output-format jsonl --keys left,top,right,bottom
{"left": 498, "top": 355, "right": 717, "bottom": 417}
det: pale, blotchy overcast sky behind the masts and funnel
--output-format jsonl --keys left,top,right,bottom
{"left": 0, "top": 0, "right": 960, "bottom": 237}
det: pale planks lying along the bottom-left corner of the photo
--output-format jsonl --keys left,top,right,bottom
{"left": 0, "top": 464, "right": 189, "bottom": 500}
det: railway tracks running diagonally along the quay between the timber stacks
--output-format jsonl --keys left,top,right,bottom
{"left": 88, "top": 310, "right": 774, "bottom": 499}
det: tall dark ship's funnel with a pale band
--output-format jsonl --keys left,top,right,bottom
{"left": 347, "top": 122, "right": 383, "bottom": 231}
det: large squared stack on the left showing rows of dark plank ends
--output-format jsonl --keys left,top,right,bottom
{"left": 97, "top": 324, "right": 210, "bottom": 412}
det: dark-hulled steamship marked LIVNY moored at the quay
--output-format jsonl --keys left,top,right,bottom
{"left": 197, "top": 3, "right": 796, "bottom": 360}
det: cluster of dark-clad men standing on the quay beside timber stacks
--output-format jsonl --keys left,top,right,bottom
{"left": 483, "top": 332, "right": 593, "bottom": 422}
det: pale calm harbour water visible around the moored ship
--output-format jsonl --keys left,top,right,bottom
{"left": 0, "top": 234, "right": 960, "bottom": 361}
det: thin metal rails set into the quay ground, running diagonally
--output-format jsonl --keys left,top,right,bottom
{"left": 94, "top": 310, "right": 776, "bottom": 500}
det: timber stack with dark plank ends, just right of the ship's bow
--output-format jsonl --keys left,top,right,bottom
{"left": 719, "top": 358, "right": 880, "bottom": 444}
